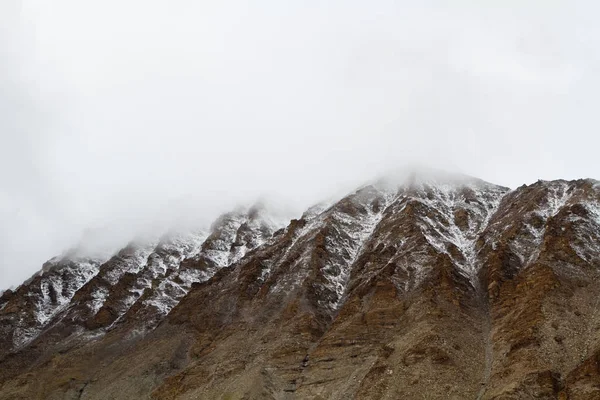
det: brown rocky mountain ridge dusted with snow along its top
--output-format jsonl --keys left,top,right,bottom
{"left": 0, "top": 176, "right": 600, "bottom": 399}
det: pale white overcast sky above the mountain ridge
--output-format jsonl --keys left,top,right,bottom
{"left": 0, "top": 0, "right": 600, "bottom": 288}
